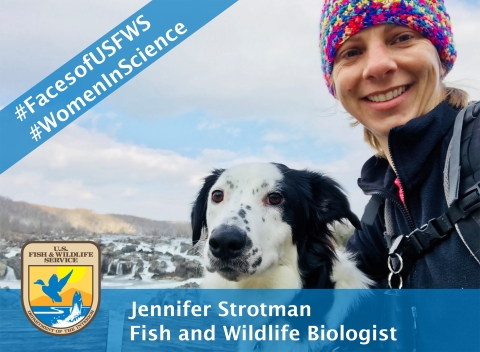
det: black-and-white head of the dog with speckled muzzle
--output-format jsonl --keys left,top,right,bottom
{"left": 191, "top": 163, "right": 360, "bottom": 287}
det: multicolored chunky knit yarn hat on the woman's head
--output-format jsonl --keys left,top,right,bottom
{"left": 320, "top": 0, "right": 457, "bottom": 95}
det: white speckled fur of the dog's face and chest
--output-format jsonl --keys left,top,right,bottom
{"left": 197, "top": 163, "right": 372, "bottom": 289}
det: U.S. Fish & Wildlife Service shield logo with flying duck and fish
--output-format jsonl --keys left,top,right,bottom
{"left": 22, "top": 241, "right": 100, "bottom": 335}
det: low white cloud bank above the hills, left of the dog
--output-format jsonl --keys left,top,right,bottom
{"left": 0, "top": 124, "right": 216, "bottom": 220}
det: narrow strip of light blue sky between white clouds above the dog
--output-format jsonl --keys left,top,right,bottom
{"left": 78, "top": 105, "right": 345, "bottom": 163}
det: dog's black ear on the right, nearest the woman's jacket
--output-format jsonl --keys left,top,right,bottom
{"left": 310, "top": 173, "right": 361, "bottom": 229}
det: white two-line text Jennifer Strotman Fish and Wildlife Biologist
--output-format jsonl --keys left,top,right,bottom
{"left": 128, "top": 300, "right": 397, "bottom": 345}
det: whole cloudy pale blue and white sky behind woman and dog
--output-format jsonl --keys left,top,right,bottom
{"left": 0, "top": 0, "right": 480, "bottom": 221}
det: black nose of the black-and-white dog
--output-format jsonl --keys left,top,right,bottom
{"left": 208, "top": 225, "right": 247, "bottom": 260}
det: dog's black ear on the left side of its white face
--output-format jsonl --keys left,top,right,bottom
{"left": 190, "top": 169, "right": 225, "bottom": 245}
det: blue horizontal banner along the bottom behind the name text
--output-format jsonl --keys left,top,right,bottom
{"left": 0, "top": 289, "right": 480, "bottom": 352}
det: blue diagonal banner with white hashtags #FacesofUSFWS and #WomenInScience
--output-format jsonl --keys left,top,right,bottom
{"left": 0, "top": 0, "right": 237, "bottom": 173}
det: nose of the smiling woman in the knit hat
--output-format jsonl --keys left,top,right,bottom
{"left": 363, "top": 43, "right": 397, "bottom": 80}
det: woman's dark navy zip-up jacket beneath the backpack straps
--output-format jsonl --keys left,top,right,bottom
{"left": 346, "top": 102, "right": 480, "bottom": 288}
